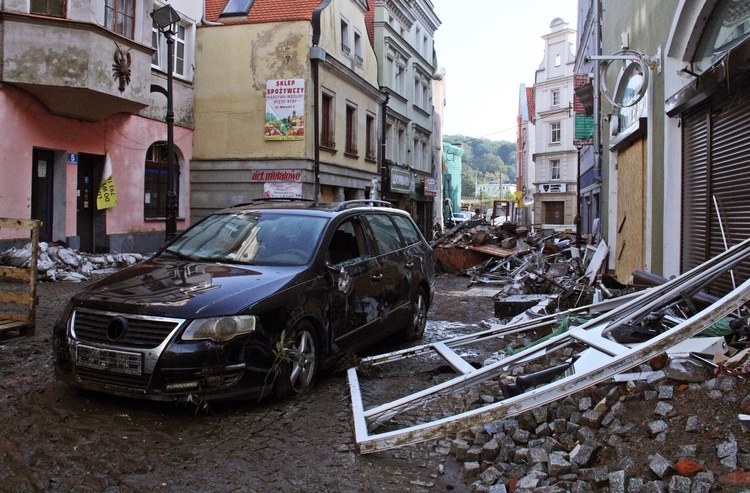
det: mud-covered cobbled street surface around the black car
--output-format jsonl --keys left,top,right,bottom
{"left": 0, "top": 274, "right": 493, "bottom": 492}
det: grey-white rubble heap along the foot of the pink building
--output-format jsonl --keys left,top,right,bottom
{"left": 0, "top": 242, "right": 144, "bottom": 282}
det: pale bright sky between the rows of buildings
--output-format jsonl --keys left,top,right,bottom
{"left": 432, "top": 0, "right": 578, "bottom": 142}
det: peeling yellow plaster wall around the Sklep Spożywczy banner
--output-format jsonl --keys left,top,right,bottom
{"left": 191, "top": 0, "right": 382, "bottom": 221}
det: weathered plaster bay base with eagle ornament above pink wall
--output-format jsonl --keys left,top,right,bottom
{"left": 0, "top": 12, "right": 152, "bottom": 122}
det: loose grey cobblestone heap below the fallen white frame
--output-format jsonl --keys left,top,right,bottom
{"left": 451, "top": 365, "right": 750, "bottom": 493}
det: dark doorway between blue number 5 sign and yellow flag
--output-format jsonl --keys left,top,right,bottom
{"left": 76, "top": 154, "right": 109, "bottom": 253}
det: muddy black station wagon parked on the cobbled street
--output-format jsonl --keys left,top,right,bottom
{"left": 53, "top": 200, "right": 435, "bottom": 401}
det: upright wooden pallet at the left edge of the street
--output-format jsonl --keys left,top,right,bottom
{"left": 0, "top": 217, "right": 39, "bottom": 336}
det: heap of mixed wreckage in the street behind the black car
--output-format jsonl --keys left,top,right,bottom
{"left": 432, "top": 220, "right": 629, "bottom": 317}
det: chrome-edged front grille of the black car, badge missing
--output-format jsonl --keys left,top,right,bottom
{"left": 72, "top": 309, "right": 182, "bottom": 349}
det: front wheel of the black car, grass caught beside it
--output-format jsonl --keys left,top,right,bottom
{"left": 274, "top": 322, "right": 318, "bottom": 398}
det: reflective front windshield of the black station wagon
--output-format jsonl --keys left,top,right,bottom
{"left": 165, "top": 211, "right": 328, "bottom": 265}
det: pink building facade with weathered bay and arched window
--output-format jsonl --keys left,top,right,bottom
{"left": 0, "top": 0, "right": 201, "bottom": 252}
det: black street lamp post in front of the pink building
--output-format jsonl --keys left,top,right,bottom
{"left": 151, "top": 5, "right": 180, "bottom": 240}
